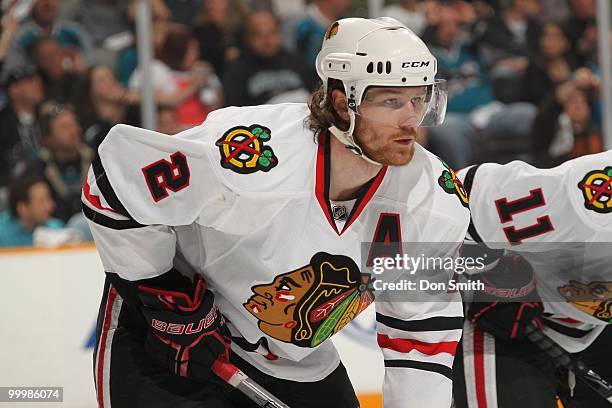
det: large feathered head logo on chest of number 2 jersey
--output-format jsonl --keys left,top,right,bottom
{"left": 243, "top": 252, "right": 374, "bottom": 347}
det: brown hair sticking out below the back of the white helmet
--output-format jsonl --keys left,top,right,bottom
{"left": 306, "top": 79, "right": 349, "bottom": 139}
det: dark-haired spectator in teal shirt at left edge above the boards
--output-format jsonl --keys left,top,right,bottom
{"left": 0, "top": 176, "right": 64, "bottom": 247}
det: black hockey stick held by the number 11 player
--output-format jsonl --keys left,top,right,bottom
{"left": 525, "top": 323, "right": 612, "bottom": 404}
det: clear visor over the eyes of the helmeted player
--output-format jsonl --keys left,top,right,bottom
{"left": 356, "top": 79, "right": 448, "bottom": 128}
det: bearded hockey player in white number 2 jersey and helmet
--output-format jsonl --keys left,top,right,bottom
{"left": 83, "top": 18, "right": 469, "bottom": 408}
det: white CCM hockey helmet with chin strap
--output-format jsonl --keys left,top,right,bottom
{"left": 316, "top": 17, "right": 447, "bottom": 161}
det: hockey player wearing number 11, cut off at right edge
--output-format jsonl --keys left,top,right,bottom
{"left": 455, "top": 151, "right": 612, "bottom": 408}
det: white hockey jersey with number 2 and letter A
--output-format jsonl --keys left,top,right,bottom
{"left": 83, "top": 104, "right": 469, "bottom": 408}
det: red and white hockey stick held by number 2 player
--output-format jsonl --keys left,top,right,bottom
{"left": 212, "top": 359, "right": 289, "bottom": 408}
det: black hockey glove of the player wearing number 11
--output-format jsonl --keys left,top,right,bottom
{"left": 468, "top": 255, "right": 543, "bottom": 340}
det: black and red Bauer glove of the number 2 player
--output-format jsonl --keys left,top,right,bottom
{"left": 138, "top": 275, "right": 231, "bottom": 380}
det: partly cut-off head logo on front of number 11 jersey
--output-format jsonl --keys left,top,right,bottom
{"left": 558, "top": 280, "right": 612, "bottom": 323}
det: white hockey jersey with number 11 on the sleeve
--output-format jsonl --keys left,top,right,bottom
{"left": 458, "top": 151, "right": 612, "bottom": 352}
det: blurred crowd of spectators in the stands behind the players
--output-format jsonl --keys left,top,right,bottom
{"left": 0, "top": 0, "right": 610, "bottom": 246}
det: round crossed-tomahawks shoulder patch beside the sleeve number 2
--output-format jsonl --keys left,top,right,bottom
{"left": 215, "top": 125, "right": 278, "bottom": 174}
